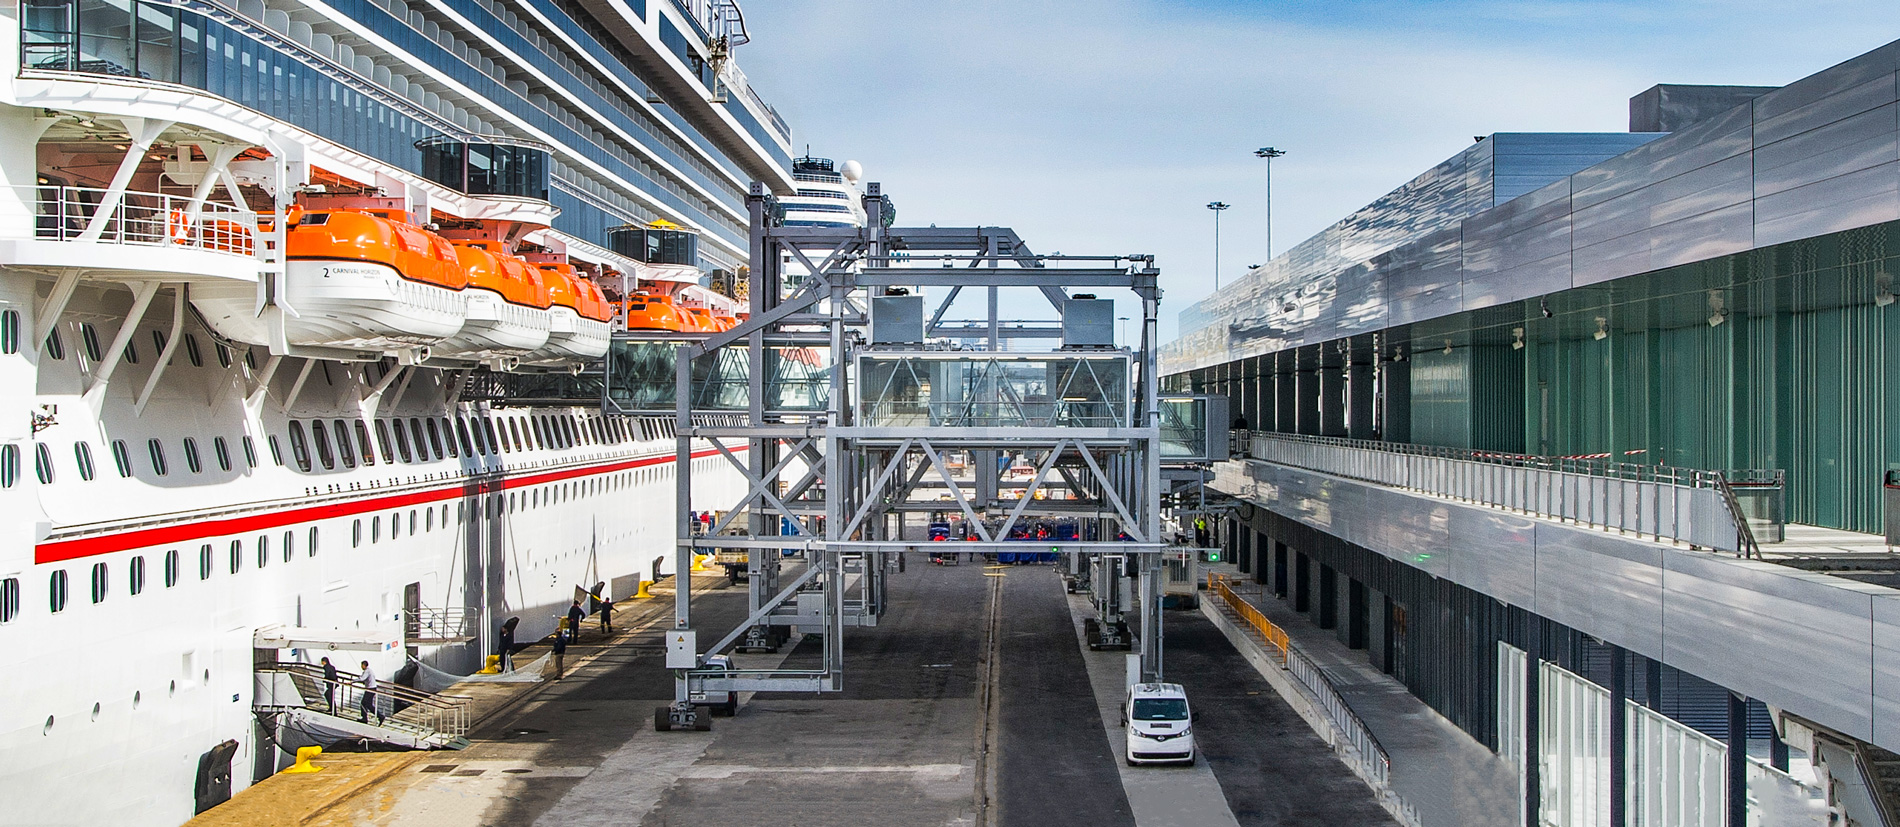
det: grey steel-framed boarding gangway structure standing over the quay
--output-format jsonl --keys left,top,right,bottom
{"left": 638, "top": 183, "right": 1226, "bottom": 730}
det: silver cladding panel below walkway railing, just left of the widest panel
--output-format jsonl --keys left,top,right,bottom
{"left": 1530, "top": 521, "right": 1663, "bottom": 660}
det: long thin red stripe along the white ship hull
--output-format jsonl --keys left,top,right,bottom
{"left": 32, "top": 447, "right": 745, "bottom": 565}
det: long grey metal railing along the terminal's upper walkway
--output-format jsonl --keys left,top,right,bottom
{"left": 1252, "top": 432, "right": 1778, "bottom": 557}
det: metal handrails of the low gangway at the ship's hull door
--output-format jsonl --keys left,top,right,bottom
{"left": 255, "top": 662, "right": 469, "bottom": 738}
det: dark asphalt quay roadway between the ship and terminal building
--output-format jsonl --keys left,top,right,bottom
{"left": 352, "top": 555, "right": 1393, "bottom": 827}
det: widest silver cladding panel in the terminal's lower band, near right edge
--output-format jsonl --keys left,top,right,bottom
{"left": 1663, "top": 549, "right": 1892, "bottom": 743}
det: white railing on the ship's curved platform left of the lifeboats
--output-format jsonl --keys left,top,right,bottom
{"left": 0, "top": 184, "right": 258, "bottom": 255}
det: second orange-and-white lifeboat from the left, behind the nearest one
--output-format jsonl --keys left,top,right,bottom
{"left": 435, "top": 241, "right": 555, "bottom": 367}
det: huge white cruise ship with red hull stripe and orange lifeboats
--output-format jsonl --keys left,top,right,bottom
{"left": 0, "top": 0, "right": 798, "bottom": 825}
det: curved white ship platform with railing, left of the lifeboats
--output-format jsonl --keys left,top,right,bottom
{"left": 0, "top": 184, "right": 272, "bottom": 283}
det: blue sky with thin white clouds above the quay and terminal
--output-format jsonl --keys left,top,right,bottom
{"left": 737, "top": 0, "right": 1900, "bottom": 338}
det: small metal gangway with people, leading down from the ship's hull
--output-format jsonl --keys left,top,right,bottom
{"left": 253, "top": 662, "right": 469, "bottom": 749}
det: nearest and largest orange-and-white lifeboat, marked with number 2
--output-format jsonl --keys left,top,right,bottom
{"left": 192, "top": 194, "right": 469, "bottom": 356}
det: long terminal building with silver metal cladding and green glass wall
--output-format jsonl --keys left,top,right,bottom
{"left": 1161, "top": 35, "right": 1900, "bottom": 827}
